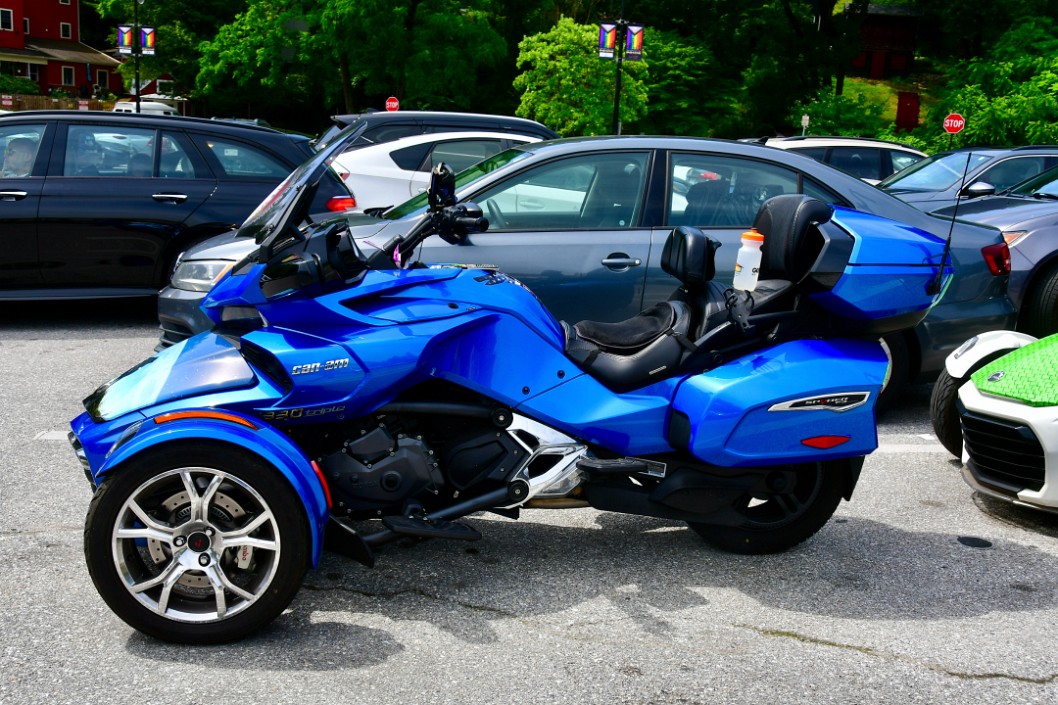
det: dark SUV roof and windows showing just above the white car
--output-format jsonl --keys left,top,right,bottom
{"left": 313, "top": 110, "right": 559, "bottom": 149}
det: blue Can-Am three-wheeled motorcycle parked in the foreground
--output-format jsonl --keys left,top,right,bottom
{"left": 71, "top": 161, "right": 950, "bottom": 644}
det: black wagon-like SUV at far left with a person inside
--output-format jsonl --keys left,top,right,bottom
{"left": 0, "top": 110, "right": 321, "bottom": 299}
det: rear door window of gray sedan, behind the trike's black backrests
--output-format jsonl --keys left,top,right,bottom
{"left": 668, "top": 153, "right": 801, "bottom": 228}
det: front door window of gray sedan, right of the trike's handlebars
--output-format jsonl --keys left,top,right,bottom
{"left": 474, "top": 151, "right": 647, "bottom": 231}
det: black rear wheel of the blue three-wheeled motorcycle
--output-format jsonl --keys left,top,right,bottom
{"left": 688, "top": 460, "right": 850, "bottom": 555}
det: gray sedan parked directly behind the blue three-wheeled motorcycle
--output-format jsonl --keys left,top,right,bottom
{"left": 159, "top": 137, "right": 1015, "bottom": 398}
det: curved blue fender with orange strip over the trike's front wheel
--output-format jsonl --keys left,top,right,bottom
{"left": 95, "top": 410, "right": 329, "bottom": 567}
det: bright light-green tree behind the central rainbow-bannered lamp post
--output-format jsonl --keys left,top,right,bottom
{"left": 514, "top": 17, "right": 647, "bottom": 137}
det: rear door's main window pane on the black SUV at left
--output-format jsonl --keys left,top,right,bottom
{"left": 62, "top": 125, "right": 154, "bottom": 177}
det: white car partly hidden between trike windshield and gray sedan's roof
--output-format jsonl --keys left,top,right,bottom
{"left": 331, "top": 132, "right": 540, "bottom": 211}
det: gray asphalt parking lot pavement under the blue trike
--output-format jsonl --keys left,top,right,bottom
{"left": 0, "top": 302, "right": 1058, "bottom": 705}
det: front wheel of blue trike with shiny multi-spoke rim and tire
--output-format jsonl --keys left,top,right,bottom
{"left": 85, "top": 442, "right": 310, "bottom": 644}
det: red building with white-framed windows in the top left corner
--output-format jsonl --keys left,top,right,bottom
{"left": 0, "top": 0, "right": 122, "bottom": 97}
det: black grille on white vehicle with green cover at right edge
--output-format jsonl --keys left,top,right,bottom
{"left": 961, "top": 411, "right": 1045, "bottom": 493}
